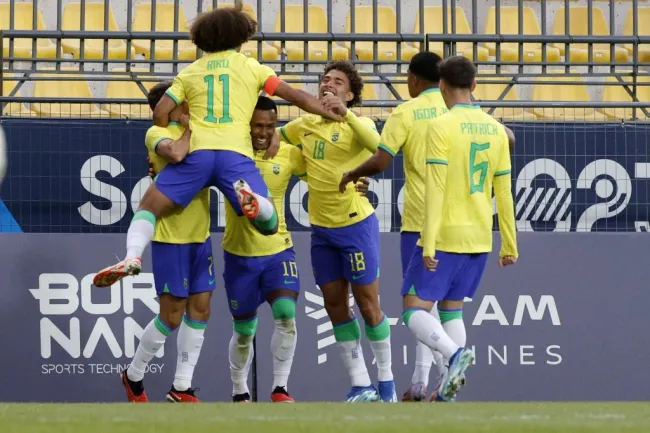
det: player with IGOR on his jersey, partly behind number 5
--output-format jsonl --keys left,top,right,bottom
{"left": 340, "top": 51, "right": 448, "bottom": 401}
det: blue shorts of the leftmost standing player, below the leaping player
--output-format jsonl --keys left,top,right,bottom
{"left": 151, "top": 237, "right": 216, "bottom": 298}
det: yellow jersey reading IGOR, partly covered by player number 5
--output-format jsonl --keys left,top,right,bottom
{"left": 379, "top": 88, "right": 449, "bottom": 232}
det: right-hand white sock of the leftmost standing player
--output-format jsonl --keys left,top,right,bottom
{"left": 174, "top": 316, "right": 207, "bottom": 391}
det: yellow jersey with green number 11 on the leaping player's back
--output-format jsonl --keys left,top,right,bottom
{"left": 167, "top": 50, "right": 277, "bottom": 158}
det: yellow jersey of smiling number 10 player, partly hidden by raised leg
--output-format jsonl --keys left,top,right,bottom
{"left": 221, "top": 143, "right": 305, "bottom": 257}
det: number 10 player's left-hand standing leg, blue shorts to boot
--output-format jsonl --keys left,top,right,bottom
{"left": 223, "top": 251, "right": 262, "bottom": 402}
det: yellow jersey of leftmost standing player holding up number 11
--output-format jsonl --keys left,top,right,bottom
{"left": 144, "top": 122, "right": 210, "bottom": 244}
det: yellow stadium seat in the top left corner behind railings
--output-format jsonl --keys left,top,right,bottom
{"left": 0, "top": 2, "right": 56, "bottom": 59}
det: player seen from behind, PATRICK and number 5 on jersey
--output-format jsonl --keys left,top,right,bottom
{"left": 402, "top": 56, "right": 518, "bottom": 401}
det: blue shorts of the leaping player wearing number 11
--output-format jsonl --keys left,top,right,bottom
{"left": 156, "top": 150, "right": 269, "bottom": 215}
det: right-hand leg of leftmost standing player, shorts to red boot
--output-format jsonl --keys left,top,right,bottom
{"left": 167, "top": 237, "right": 216, "bottom": 402}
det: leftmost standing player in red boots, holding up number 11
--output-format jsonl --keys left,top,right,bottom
{"left": 122, "top": 81, "right": 216, "bottom": 402}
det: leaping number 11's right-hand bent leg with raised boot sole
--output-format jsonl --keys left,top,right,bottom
{"left": 211, "top": 150, "right": 278, "bottom": 235}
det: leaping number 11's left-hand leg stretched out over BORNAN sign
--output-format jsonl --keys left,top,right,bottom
{"left": 93, "top": 150, "right": 213, "bottom": 287}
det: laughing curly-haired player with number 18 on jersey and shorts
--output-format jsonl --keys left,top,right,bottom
{"left": 280, "top": 61, "right": 397, "bottom": 401}
